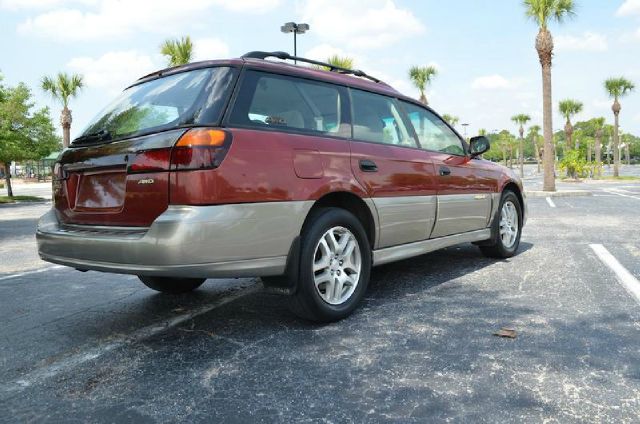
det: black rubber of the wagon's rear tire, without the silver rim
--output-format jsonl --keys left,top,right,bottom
{"left": 289, "top": 208, "right": 371, "bottom": 322}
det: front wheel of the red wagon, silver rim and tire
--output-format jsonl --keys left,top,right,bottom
{"left": 479, "top": 190, "right": 522, "bottom": 259}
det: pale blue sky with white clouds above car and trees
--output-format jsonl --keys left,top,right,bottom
{"left": 0, "top": 0, "right": 640, "bottom": 137}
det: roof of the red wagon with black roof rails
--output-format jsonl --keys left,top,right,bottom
{"left": 132, "top": 58, "right": 418, "bottom": 102}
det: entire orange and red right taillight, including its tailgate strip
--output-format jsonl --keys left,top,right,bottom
{"left": 127, "top": 128, "right": 231, "bottom": 174}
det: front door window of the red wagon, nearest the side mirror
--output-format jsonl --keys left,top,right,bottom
{"left": 401, "top": 102, "right": 465, "bottom": 156}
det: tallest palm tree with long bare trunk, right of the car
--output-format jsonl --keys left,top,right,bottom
{"left": 523, "top": 0, "right": 575, "bottom": 191}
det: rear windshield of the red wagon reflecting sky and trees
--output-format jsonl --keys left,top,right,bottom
{"left": 74, "top": 67, "right": 237, "bottom": 144}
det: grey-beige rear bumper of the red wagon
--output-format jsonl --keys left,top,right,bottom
{"left": 36, "top": 202, "right": 313, "bottom": 278}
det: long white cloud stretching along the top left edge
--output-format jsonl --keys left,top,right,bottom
{"left": 16, "top": 0, "right": 280, "bottom": 41}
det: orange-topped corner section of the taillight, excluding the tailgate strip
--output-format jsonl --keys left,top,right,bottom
{"left": 171, "top": 128, "right": 231, "bottom": 171}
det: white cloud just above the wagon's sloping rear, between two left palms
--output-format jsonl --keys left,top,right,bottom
{"left": 67, "top": 50, "right": 162, "bottom": 96}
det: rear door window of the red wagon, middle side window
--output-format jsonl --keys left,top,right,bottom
{"left": 351, "top": 89, "right": 417, "bottom": 147}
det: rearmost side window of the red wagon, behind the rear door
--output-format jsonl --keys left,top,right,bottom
{"left": 229, "top": 71, "right": 351, "bottom": 137}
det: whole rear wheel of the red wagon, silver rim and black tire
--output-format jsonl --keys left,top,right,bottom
{"left": 289, "top": 208, "right": 371, "bottom": 322}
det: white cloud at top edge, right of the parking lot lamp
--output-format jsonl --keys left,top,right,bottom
{"left": 300, "top": 0, "right": 424, "bottom": 49}
